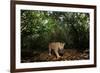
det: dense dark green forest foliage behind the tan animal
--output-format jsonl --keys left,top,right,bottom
{"left": 21, "top": 10, "right": 89, "bottom": 50}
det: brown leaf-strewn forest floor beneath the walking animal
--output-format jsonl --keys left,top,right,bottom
{"left": 21, "top": 49, "right": 89, "bottom": 63}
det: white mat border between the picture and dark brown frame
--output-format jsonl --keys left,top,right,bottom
{"left": 16, "top": 4, "right": 94, "bottom": 69}
